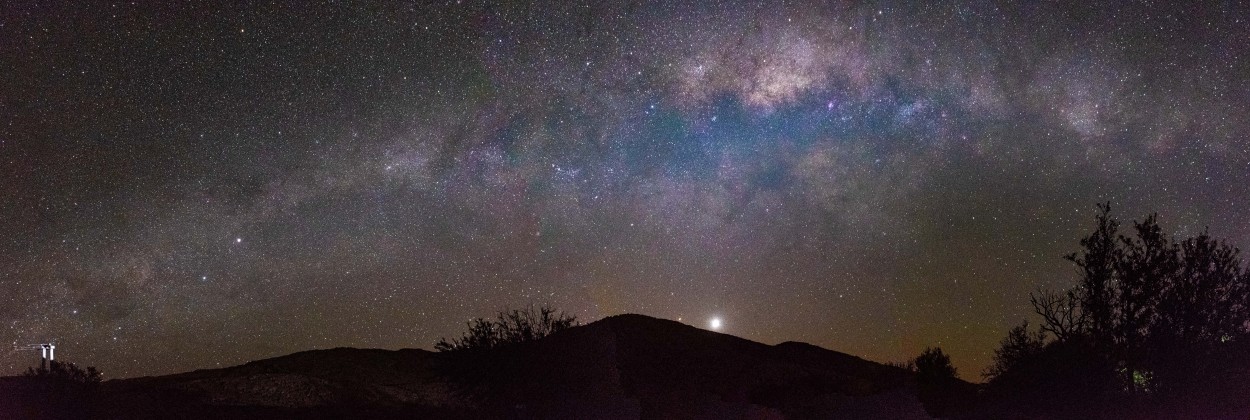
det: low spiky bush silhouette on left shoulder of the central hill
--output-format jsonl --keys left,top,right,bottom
{"left": 434, "top": 305, "right": 578, "bottom": 351}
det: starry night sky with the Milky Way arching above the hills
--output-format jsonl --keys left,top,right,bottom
{"left": 0, "top": 1, "right": 1250, "bottom": 380}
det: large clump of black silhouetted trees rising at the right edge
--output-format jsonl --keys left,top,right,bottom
{"left": 985, "top": 204, "right": 1250, "bottom": 412}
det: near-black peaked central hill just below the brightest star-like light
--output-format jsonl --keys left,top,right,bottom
{"left": 425, "top": 315, "right": 926, "bottom": 419}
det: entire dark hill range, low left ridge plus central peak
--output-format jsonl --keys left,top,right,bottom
{"left": 0, "top": 315, "right": 928, "bottom": 419}
